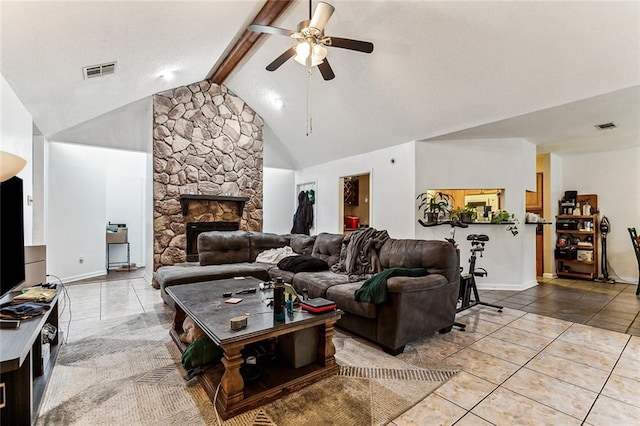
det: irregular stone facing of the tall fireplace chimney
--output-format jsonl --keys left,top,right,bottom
{"left": 153, "top": 81, "right": 264, "bottom": 270}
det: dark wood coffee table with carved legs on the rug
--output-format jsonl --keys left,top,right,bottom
{"left": 166, "top": 277, "right": 342, "bottom": 420}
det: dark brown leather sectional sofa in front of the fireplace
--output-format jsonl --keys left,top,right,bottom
{"left": 156, "top": 231, "right": 460, "bottom": 355}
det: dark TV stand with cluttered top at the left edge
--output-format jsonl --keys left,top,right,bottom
{"left": 0, "top": 287, "right": 62, "bottom": 426}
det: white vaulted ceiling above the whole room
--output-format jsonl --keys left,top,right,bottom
{"left": 0, "top": 0, "right": 640, "bottom": 167}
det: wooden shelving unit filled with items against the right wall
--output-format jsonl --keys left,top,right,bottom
{"left": 555, "top": 194, "right": 599, "bottom": 280}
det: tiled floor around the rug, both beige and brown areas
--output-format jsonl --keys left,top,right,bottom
{"left": 60, "top": 274, "right": 640, "bottom": 426}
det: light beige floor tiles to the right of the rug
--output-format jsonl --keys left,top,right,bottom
{"left": 392, "top": 307, "right": 640, "bottom": 426}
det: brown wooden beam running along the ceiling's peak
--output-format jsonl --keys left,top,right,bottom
{"left": 208, "top": 0, "right": 293, "bottom": 84}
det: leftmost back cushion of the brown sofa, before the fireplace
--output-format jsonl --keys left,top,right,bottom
{"left": 198, "top": 231, "right": 255, "bottom": 266}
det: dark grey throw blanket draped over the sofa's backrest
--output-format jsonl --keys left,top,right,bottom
{"left": 331, "top": 228, "right": 389, "bottom": 282}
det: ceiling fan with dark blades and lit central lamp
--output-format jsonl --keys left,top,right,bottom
{"left": 249, "top": 0, "right": 373, "bottom": 80}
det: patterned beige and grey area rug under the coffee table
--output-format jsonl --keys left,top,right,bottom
{"left": 37, "top": 313, "right": 457, "bottom": 426}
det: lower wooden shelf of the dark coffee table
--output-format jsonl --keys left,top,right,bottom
{"left": 170, "top": 330, "right": 340, "bottom": 420}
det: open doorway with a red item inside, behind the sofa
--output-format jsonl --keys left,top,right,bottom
{"left": 338, "top": 172, "right": 371, "bottom": 234}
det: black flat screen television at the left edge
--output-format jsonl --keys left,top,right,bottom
{"left": 0, "top": 177, "right": 25, "bottom": 297}
